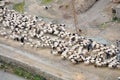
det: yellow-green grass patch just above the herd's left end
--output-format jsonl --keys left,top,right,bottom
{"left": 13, "top": 0, "right": 25, "bottom": 13}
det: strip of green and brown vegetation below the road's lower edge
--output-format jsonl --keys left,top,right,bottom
{"left": 0, "top": 61, "right": 46, "bottom": 80}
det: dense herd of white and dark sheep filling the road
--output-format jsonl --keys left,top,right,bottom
{"left": 0, "top": 0, "right": 120, "bottom": 69}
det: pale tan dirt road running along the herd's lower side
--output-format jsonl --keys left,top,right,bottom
{"left": 0, "top": 37, "right": 120, "bottom": 80}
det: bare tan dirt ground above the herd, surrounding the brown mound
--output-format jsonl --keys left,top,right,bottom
{"left": 11, "top": 0, "right": 120, "bottom": 44}
